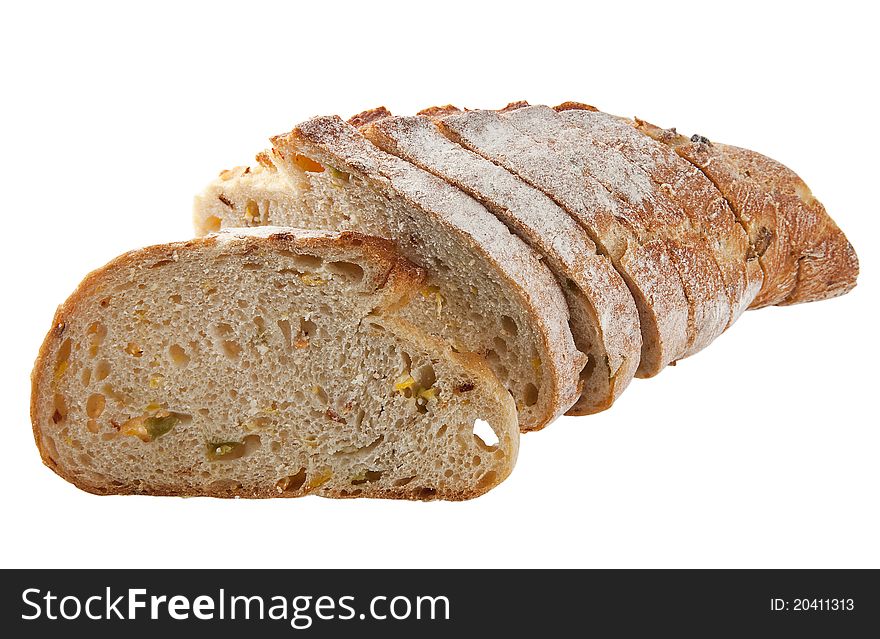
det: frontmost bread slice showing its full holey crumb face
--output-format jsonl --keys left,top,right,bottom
{"left": 32, "top": 227, "right": 519, "bottom": 499}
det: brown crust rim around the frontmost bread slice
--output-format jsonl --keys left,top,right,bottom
{"left": 30, "top": 227, "right": 519, "bottom": 501}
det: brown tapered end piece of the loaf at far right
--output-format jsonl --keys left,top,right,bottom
{"left": 630, "top": 119, "right": 859, "bottom": 308}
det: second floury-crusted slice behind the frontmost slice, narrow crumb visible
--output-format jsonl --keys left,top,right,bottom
{"left": 360, "top": 114, "right": 641, "bottom": 415}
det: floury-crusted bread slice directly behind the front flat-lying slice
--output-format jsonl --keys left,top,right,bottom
{"left": 194, "top": 116, "right": 587, "bottom": 430}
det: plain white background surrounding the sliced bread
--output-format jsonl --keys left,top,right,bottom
{"left": 0, "top": 0, "right": 880, "bottom": 567}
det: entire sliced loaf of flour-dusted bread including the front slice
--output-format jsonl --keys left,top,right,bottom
{"left": 32, "top": 102, "right": 858, "bottom": 499}
